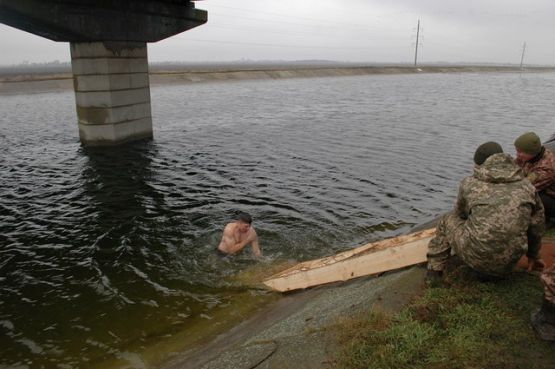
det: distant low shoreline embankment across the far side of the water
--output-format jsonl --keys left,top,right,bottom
{"left": 0, "top": 64, "right": 555, "bottom": 95}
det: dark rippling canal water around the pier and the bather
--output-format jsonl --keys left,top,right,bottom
{"left": 0, "top": 73, "right": 555, "bottom": 369}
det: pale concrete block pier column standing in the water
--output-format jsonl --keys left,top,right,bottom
{"left": 70, "top": 42, "right": 152, "bottom": 146}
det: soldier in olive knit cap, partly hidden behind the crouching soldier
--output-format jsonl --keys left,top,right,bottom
{"left": 515, "top": 132, "right": 555, "bottom": 219}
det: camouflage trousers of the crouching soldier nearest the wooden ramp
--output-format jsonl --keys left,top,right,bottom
{"left": 427, "top": 213, "right": 467, "bottom": 270}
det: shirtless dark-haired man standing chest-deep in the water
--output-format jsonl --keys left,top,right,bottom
{"left": 218, "top": 213, "right": 262, "bottom": 258}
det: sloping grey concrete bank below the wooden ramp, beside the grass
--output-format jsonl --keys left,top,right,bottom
{"left": 161, "top": 267, "right": 425, "bottom": 369}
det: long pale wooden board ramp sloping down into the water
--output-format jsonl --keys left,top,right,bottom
{"left": 263, "top": 228, "right": 436, "bottom": 292}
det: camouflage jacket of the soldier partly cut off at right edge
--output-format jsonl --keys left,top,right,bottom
{"left": 516, "top": 147, "right": 555, "bottom": 197}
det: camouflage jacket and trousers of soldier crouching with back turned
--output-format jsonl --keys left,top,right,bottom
{"left": 428, "top": 153, "right": 544, "bottom": 276}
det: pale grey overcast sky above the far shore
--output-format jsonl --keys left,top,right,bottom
{"left": 0, "top": 0, "right": 555, "bottom": 65}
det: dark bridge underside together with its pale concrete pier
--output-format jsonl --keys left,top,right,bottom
{"left": 0, "top": 0, "right": 207, "bottom": 145}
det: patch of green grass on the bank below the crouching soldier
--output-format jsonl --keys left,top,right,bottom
{"left": 332, "top": 267, "right": 555, "bottom": 369}
